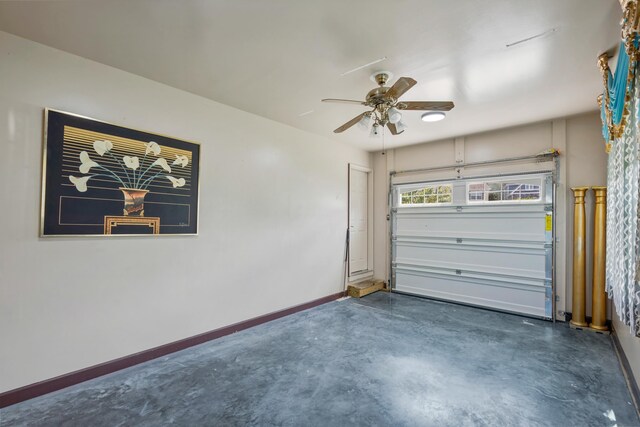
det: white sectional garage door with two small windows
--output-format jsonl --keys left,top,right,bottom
{"left": 391, "top": 174, "right": 553, "bottom": 319}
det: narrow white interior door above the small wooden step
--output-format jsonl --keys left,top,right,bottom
{"left": 349, "top": 166, "right": 370, "bottom": 276}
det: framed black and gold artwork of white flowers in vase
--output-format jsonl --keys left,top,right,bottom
{"left": 40, "top": 109, "right": 200, "bottom": 236}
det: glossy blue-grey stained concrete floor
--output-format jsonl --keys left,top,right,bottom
{"left": 0, "top": 292, "right": 640, "bottom": 427}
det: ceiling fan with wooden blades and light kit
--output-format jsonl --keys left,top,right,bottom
{"left": 322, "top": 71, "right": 454, "bottom": 136}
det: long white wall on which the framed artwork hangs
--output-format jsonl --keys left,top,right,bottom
{"left": 0, "top": 32, "right": 369, "bottom": 392}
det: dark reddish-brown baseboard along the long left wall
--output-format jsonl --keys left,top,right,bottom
{"left": 0, "top": 291, "right": 346, "bottom": 408}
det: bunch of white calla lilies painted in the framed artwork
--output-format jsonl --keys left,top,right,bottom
{"left": 69, "top": 139, "right": 189, "bottom": 193}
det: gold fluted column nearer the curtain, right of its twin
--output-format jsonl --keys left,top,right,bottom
{"left": 589, "top": 187, "right": 609, "bottom": 331}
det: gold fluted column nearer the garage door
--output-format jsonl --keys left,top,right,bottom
{"left": 570, "top": 187, "right": 589, "bottom": 327}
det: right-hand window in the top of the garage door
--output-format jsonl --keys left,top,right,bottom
{"left": 467, "top": 178, "right": 542, "bottom": 203}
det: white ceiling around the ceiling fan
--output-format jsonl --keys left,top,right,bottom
{"left": 0, "top": 0, "right": 621, "bottom": 151}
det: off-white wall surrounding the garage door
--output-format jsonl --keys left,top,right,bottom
{"left": 372, "top": 112, "right": 606, "bottom": 318}
